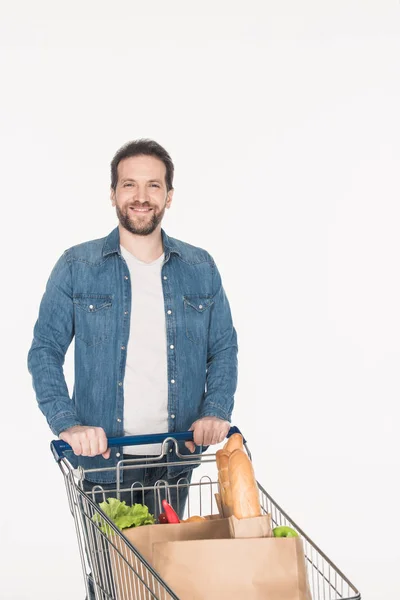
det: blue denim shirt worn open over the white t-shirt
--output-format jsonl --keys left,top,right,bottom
{"left": 28, "top": 228, "right": 237, "bottom": 483}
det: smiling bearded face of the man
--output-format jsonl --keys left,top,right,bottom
{"left": 111, "top": 156, "right": 173, "bottom": 235}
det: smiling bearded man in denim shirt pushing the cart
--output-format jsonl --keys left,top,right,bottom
{"left": 28, "top": 140, "right": 237, "bottom": 515}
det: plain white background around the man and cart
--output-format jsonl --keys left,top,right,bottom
{"left": 0, "top": 0, "right": 400, "bottom": 600}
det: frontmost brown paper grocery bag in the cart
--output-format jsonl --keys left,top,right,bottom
{"left": 153, "top": 538, "right": 311, "bottom": 600}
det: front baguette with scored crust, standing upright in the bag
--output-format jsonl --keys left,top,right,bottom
{"left": 228, "top": 448, "right": 261, "bottom": 519}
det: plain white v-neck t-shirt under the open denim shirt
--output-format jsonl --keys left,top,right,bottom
{"left": 121, "top": 246, "right": 168, "bottom": 455}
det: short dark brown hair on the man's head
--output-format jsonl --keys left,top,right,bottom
{"left": 111, "top": 139, "right": 174, "bottom": 192}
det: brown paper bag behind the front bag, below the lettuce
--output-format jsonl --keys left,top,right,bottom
{"left": 110, "top": 515, "right": 230, "bottom": 600}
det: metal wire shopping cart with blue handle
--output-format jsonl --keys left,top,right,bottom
{"left": 51, "top": 427, "right": 361, "bottom": 600}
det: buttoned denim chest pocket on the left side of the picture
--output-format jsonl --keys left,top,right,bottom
{"left": 73, "top": 294, "right": 112, "bottom": 346}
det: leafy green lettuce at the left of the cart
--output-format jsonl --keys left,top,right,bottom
{"left": 93, "top": 498, "right": 155, "bottom": 535}
